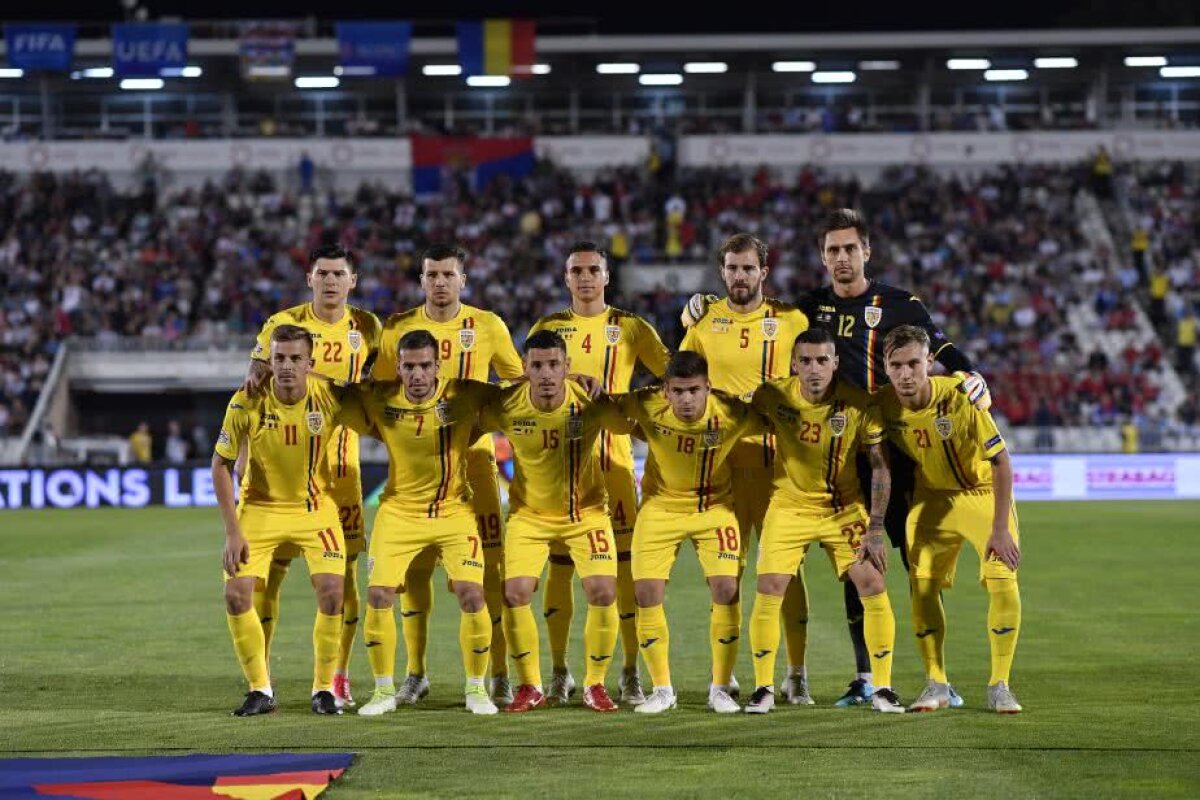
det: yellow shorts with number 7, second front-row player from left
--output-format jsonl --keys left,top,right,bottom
{"left": 367, "top": 503, "right": 484, "bottom": 587}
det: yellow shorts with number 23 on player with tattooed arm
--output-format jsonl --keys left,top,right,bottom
{"left": 758, "top": 503, "right": 869, "bottom": 581}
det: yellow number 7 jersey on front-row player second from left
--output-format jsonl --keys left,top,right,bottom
{"left": 343, "top": 379, "right": 498, "bottom": 519}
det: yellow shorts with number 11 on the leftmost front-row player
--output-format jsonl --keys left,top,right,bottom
{"left": 226, "top": 500, "right": 346, "bottom": 581}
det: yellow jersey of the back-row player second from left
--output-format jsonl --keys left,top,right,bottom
{"left": 371, "top": 303, "right": 524, "bottom": 462}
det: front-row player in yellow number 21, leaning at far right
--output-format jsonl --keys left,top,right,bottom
{"left": 876, "top": 325, "right": 1021, "bottom": 714}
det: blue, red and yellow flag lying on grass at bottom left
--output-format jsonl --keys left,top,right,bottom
{"left": 0, "top": 753, "right": 354, "bottom": 800}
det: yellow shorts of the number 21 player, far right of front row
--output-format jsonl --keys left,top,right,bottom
{"left": 907, "top": 489, "right": 1021, "bottom": 588}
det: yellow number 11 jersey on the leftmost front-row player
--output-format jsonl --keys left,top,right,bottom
{"left": 216, "top": 375, "right": 350, "bottom": 512}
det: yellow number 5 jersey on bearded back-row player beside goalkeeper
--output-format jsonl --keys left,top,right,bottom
{"left": 679, "top": 297, "right": 809, "bottom": 469}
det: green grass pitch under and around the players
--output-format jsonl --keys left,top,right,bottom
{"left": 0, "top": 501, "right": 1200, "bottom": 800}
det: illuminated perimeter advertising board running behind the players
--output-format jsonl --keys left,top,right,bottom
{"left": 0, "top": 453, "right": 1200, "bottom": 510}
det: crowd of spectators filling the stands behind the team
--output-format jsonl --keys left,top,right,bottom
{"left": 0, "top": 157, "right": 1200, "bottom": 448}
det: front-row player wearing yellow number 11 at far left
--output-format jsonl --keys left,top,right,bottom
{"left": 212, "top": 325, "right": 355, "bottom": 716}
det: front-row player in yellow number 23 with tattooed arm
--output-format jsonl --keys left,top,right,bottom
{"left": 745, "top": 327, "right": 904, "bottom": 714}
